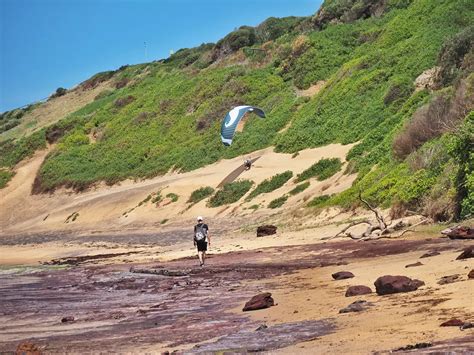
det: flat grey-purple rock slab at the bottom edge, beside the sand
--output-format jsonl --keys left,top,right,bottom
{"left": 192, "top": 320, "right": 336, "bottom": 353}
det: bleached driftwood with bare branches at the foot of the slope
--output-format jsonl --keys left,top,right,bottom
{"left": 332, "top": 191, "right": 429, "bottom": 240}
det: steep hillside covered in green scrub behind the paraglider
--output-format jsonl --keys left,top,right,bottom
{"left": 0, "top": 0, "right": 474, "bottom": 220}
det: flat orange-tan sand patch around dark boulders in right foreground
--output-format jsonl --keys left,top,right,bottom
{"left": 243, "top": 252, "right": 474, "bottom": 354}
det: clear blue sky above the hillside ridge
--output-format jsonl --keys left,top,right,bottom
{"left": 0, "top": 0, "right": 321, "bottom": 112}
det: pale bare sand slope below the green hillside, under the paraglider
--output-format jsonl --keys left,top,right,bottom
{"left": 0, "top": 144, "right": 356, "bottom": 235}
